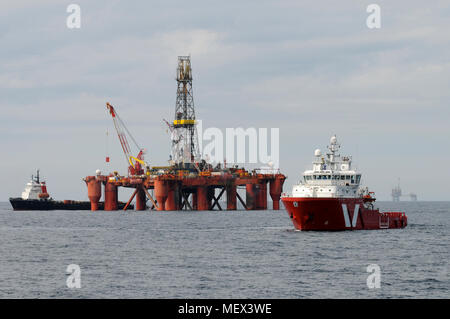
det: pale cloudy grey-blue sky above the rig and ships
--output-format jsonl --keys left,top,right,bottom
{"left": 0, "top": 0, "right": 450, "bottom": 201}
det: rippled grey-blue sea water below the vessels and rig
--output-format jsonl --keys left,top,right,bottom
{"left": 0, "top": 202, "right": 450, "bottom": 298}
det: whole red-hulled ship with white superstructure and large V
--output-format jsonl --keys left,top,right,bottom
{"left": 281, "top": 135, "right": 408, "bottom": 231}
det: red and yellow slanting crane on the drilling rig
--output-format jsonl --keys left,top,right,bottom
{"left": 106, "top": 102, "right": 148, "bottom": 175}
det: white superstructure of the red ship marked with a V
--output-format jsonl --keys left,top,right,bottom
{"left": 292, "top": 135, "right": 361, "bottom": 198}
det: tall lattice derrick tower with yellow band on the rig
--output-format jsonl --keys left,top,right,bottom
{"left": 171, "top": 56, "right": 200, "bottom": 168}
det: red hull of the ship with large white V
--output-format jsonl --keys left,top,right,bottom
{"left": 282, "top": 197, "right": 407, "bottom": 231}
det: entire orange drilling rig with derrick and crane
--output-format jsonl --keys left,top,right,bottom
{"left": 84, "top": 56, "right": 286, "bottom": 211}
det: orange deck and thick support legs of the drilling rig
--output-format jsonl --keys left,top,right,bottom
{"left": 84, "top": 170, "right": 286, "bottom": 211}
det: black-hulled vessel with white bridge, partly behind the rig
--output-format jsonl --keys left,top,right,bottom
{"left": 9, "top": 170, "right": 134, "bottom": 210}
